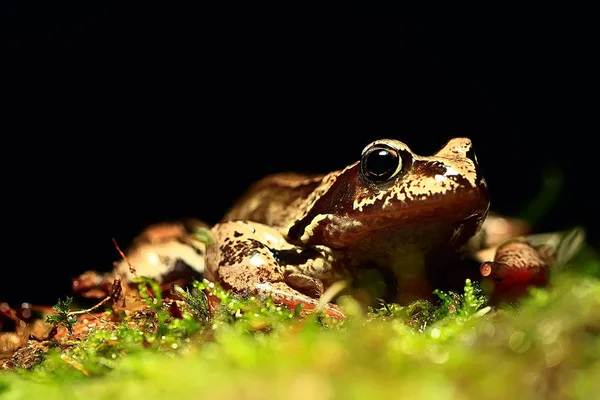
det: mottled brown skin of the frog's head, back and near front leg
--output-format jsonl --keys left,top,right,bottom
{"left": 206, "top": 138, "right": 489, "bottom": 313}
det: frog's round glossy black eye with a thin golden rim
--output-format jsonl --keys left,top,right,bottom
{"left": 360, "top": 144, "right": 402, "bottom": 182}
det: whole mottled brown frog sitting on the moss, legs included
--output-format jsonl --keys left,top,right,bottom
{"left": 74, "top": 137, "right": 576, "bottom": 318}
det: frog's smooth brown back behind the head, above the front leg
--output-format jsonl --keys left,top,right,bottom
{"left": 222, "top": 172, "right": 324, "bottom": 227}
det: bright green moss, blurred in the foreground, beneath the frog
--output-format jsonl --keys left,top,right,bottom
{"left": 0, "top": 250, "right": 600, "bottom": 400}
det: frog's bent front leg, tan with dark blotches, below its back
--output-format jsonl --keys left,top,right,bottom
{"left": 206, "top": 221, "right": 345, "bottom": 318}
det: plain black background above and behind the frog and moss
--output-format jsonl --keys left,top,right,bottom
{"left": 0, "top": 1, "right": 598, "bottom": 304}
